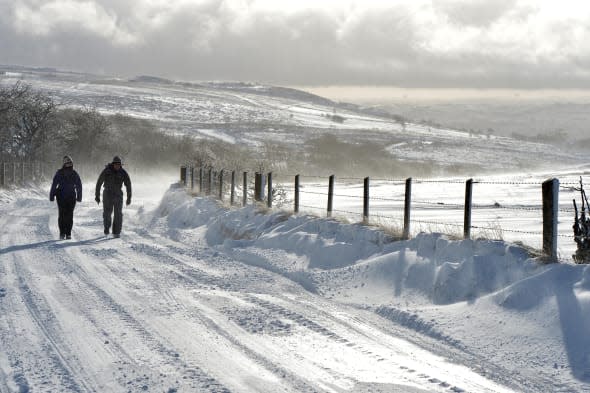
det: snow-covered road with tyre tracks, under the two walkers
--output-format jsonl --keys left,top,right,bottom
{"left": 0, "top": 178, "right": 560, "bottom": 392}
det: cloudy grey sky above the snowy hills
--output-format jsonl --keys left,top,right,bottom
{"left": 0, "top": 0, "right": 590, "bottom": 88}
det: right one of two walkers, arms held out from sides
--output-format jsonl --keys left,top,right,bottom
{"left": 94, "top": 156, "right": 131, "bottom": 237}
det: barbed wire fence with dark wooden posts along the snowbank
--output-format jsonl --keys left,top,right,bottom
{"left": 181, "top": 165, "right": 590, "bottom": 260}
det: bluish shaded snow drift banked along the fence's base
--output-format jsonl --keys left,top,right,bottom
{"left": 157, "top": 186, "right": 568, "bottom": 308}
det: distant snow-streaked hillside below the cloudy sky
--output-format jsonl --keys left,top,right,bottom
{"left": 0, "top": 67, "right": 585, "bottom": 176}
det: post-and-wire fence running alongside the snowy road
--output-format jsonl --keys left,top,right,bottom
{"left": 181, "top": 165, "right": 590, "bottom": 260}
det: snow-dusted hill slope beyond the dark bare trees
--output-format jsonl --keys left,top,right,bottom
{"left": 0, "top": 66, "right": 581, "bottom": 175}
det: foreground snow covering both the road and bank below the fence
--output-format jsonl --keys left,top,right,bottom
{"left": 0, "top": 174, "right": 590, "bottom": 392}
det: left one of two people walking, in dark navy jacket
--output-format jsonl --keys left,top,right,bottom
{"left": 49, "top": 156, "right": 82, "bottom": 239}
